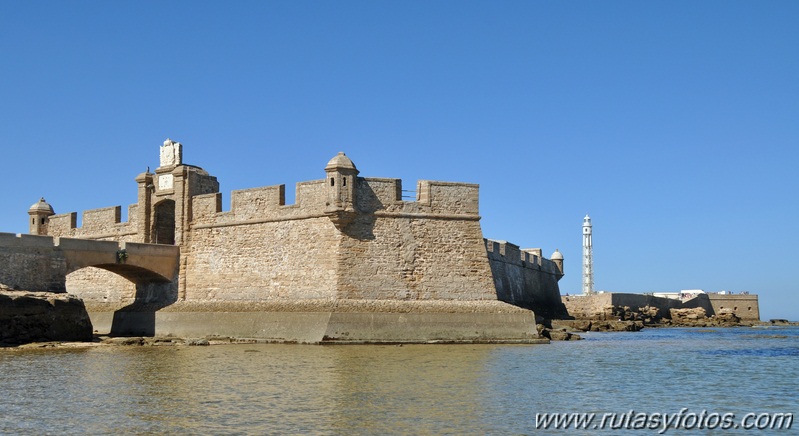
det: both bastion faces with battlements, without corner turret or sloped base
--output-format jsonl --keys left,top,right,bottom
{"left": 186, "top": 178, "right": 496, "bottom": 300}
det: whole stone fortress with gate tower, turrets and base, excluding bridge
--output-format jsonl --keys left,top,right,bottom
{"left": 18, "top": 139, "right": 567, "bottom": 343}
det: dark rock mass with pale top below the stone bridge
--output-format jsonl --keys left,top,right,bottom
{"left": 0, "top": 285, "right": 92, "bottom": 345}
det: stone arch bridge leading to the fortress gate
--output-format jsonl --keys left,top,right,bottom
{"left": 0, "top": 233, "right": 180, "bottom": 292}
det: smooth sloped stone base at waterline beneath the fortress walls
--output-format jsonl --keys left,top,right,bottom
{"left": 90, "top": 300, "right": 548, "bottom": 344}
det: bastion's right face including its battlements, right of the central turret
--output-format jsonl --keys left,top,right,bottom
{"left": 338, "top": 178, "right": 497, "bottom": 300}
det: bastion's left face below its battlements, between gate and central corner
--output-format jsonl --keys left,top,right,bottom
{"left": 183, "top": 216, "right": 339, "bottom": 301}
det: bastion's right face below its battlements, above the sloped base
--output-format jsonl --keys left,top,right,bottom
{"left": 338, "top": 214, "right": 497, "bottom": 300}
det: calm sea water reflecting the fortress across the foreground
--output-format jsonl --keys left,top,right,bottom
{"left": 0, "top": 327, "right": 799, "bottom": 434}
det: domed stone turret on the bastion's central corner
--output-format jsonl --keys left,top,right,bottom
{"left": 325, "top": 152, "right": 359, "bottom": 230}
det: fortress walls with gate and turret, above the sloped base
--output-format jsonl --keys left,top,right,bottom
{"left": 18, "top": 146, "right": 563, "bottom": 334}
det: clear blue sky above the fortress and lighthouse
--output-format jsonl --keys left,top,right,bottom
{"left": 0, "top": 0, "right": 799, "bottom": 319}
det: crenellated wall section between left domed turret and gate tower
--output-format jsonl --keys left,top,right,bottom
{"left": 47, "top": 204, "right": 138, "bottom": 238}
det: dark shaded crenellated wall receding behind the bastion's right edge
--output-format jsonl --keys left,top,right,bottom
{"left": 484, "top": 239, "right": 566, "bottom": 318}
